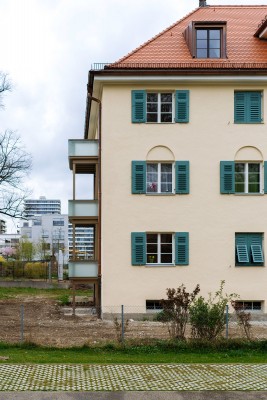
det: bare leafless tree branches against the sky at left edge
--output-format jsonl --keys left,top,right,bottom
{"left": 0, "top": 72, "right": 32, "bottom": 218}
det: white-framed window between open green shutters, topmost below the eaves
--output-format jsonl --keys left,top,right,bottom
{"left": 146, "top": 93, "right": 173, "bottom": 122}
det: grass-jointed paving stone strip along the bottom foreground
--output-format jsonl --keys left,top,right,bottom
{"left": 0, "top": 364, "right": 267, "bottom": 391}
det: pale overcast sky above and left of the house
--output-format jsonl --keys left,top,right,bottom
{"left": 0, "top": 0, "right": 267, "bottom": 231}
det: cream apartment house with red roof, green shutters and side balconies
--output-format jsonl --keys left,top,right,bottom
{"left": 69, "top": 1, "right": 267, "bottom": 313}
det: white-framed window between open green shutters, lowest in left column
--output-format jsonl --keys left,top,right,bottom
{"left": 146, "top": 233, "right": 174, "bottom": 264}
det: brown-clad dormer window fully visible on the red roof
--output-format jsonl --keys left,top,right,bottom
{"left": 184, "top": 21, "right": 226, "bottom": 59}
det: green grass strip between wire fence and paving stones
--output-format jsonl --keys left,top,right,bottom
{"left": 0, "top": 341, "right": 267, "bottom": 364}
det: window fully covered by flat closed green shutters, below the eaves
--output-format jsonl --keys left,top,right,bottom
{"left": 234, "top": 91, "right": 262, "bottom": 124}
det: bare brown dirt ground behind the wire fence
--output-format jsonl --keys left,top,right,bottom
{"left": 0, "top": 296, "right": 267, "bottom": 347}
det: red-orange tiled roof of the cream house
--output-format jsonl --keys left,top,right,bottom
{"left": 110, "top": 6, "right": 267, "bottom": 69}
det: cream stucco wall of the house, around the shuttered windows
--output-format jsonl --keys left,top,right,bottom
{"left": 86, "top": 76, "right": 267, "bottom": 312}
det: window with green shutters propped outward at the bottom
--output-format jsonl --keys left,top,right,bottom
{"left": 235, "top": 233, "right": 264, "bottom": 267}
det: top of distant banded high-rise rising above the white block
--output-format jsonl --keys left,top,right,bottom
{"left": 24, "top": 196, "right": 61, "bottom": 219}
